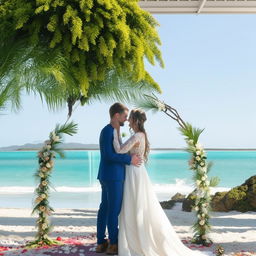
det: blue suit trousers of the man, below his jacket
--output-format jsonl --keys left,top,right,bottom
{"left": 97, "top": 181, "right": 124, "bottom": 244}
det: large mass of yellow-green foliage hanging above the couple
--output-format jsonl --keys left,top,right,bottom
{"left": 0, "top": 0, "right": 163, "bottom": 114}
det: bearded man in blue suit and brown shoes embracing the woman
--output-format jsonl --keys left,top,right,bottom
{"left": 96, "top": 103, "right": 141, "bottom": 255}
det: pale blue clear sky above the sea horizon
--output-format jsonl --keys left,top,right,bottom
{"left": 0, "top": 14, "right": 256, "bottom": 148}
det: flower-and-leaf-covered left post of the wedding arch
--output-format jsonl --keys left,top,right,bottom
{"left": 27, "top": 122, "right": 77, "bottom": 248}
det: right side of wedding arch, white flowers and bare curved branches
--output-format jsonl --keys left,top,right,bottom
{"left": 139, "top": 94, "right": 219, "bottom": 246}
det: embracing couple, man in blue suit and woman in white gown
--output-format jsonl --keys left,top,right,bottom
{"left": 96, "top": 103, "right": 205, "bottom": 256}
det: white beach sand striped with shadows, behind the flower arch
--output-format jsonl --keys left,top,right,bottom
{"left": 0, "top": 204, "right": 256, "bottom": 254}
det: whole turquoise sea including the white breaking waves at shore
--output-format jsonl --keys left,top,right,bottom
{"left": 0, "top": 150, "right": 256, "bottom": 208}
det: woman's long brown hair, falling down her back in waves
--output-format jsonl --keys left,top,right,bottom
{"left": 129, "top": 109, "right": 150, "bottom": 161}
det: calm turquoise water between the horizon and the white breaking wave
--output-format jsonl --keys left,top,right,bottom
{"left": 0, "top": 151, "right": 256, "bottom": 187}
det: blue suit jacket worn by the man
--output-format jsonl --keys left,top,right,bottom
{"left": 98, "top": 124, "right": 131, "bottom": 181}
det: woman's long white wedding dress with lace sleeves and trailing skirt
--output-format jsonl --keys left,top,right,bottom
{"left": 113, "top": 129, "right": 209, "bottom": 256}
